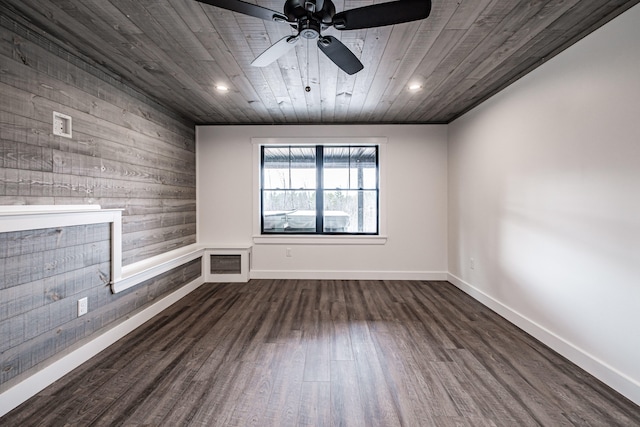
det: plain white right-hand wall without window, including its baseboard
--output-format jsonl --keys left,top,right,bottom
{"left": 448, "top": 6, "right": 640, "bottom": 403}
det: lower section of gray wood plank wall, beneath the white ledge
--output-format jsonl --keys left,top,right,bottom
{"left": 0, "top": 224, "right": 202, "bottom": 391}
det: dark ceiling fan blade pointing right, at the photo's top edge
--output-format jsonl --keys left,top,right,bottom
{"left": 333, "top": 0, "right": 431, "bottom": 30}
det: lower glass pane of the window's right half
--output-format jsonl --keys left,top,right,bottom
{"left": 324, "top": 190, "right": 378, "bottom": 233}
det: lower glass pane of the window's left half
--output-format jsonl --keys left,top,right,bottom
{"left": 262, "top": 190, "right": 316, "bottom": 233}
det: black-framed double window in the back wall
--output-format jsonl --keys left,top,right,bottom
{"left": 260, "top": 145, "right": 379, "bottom": 235}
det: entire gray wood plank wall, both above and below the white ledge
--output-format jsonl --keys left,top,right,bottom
{"left": 0, "top": 11, "right": 201, "bottom": 391}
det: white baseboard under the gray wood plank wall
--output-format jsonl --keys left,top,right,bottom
{"left": 0, "top": 277, "right": 204, "bottom": 417}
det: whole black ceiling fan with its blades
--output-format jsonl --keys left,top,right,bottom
{"left": 197, "top": 0, "right": 431, "bottom": 74}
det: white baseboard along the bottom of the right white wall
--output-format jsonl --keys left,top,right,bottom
{"left": 448, "top": 273, "right": 640, "bottom": 405}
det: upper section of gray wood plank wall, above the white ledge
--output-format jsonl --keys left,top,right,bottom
{"left": 0, "top": 10, "right": 196, "bottom": 265}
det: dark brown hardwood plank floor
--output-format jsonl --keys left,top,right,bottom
{"left": 0, "top": 280, "right": 640, "bottom": 426}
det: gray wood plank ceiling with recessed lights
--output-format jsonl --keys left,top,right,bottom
{"left": 0, "top": 0, "right": 640, "bottom": 124}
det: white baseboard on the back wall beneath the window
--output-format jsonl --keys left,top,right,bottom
{"left": 250, "top": 269, "right": 448, "bottom": 280}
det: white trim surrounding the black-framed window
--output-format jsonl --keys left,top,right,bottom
{"left": 251, "top": 137, "right": 388, "bottom": 245}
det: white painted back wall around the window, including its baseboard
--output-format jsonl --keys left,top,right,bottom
{"left": 196, "top": 125, "right": 447, "bottom": 279}
